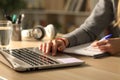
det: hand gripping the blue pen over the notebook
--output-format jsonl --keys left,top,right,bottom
{"left": 91, "top": 38, "right": 120, "bottom": 55}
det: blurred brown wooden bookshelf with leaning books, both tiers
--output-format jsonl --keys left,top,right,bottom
{"left": 21, "top": 0, "right": 98, "bottom": 33}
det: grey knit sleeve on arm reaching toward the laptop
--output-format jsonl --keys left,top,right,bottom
{"left": 63, "top": 0, "right": 114, "bottom": 47}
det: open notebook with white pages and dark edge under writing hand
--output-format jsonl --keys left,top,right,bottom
{"left": 63, "top": 43, "right": 110, "bottom": 58}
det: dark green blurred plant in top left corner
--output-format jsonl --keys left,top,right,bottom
{"left": 0, "top": 0, "right": 26, "bottom": 14}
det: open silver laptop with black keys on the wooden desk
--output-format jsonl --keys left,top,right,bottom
{"left": 0, "top": 47, "right": 84, "bottom": 72}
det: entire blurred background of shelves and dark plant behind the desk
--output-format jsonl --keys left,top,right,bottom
{"left": 0, "top": 0, "right": 98, "bottom": 33}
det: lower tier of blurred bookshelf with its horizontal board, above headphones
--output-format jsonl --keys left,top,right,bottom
{"left": 21, "top": 10, "right": 90, "bottom": 33}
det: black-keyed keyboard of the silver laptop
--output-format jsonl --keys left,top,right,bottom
{"left": 4, "top": 48, "right": 59, "bottom": 66}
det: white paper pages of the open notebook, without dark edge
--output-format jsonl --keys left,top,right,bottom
{"left": 63, "top": 43, "right": 103, "bottom": 56}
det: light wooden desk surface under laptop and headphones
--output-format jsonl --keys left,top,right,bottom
{"left": 0, "top": 41, "right": 120, "bottom": 80}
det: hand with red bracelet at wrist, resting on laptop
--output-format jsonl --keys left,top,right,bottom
{"left": 39, "top": 38, "right": 68, "bottom": 56}
